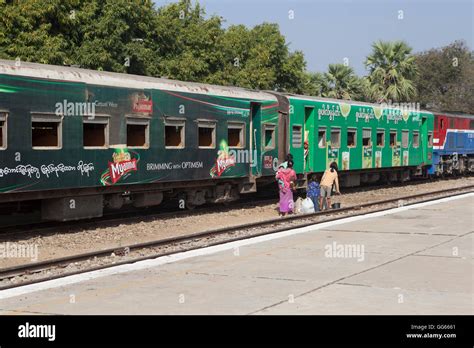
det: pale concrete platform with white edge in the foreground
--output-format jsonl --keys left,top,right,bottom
{"left": 0, "top": 194, "right": 474, "bottom": 314}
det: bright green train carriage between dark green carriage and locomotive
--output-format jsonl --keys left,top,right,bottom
{"left": 278, "top": 95, "right": 433, "bottom": 186}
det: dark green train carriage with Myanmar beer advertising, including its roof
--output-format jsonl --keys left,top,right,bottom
{"left": 0, "top": 61, "right": 279, "bottom": 220}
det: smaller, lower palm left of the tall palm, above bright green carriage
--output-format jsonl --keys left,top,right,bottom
{"left": 322, "top": 64, "right": 363, "bottom": 100}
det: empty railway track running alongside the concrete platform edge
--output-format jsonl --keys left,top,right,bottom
{"left": 0, "top": 185, "right": 474, "bottom": 290}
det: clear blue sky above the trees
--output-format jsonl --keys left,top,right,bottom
{"left": 155, "top": 0, "right": 474, "bottom": 75}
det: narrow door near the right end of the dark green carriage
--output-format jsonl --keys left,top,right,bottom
{"left": 249, "top": 103, "right": 262, "bottom": 176}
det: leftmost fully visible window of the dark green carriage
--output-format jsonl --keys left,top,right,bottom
{"left": 31, "top": 114, "right": 62, "bottom": 150}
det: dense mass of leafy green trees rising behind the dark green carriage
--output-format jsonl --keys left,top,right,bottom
{"left": 0, "top": 0, "right": 306, "bottom": 93}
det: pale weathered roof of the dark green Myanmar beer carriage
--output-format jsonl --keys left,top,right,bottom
{"left": 0, "top": 59, "right": 277, "bottom": 101}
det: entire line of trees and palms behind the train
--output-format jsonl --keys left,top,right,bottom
{"left": 0, "top": 0, "right": 474, "bottom": 113}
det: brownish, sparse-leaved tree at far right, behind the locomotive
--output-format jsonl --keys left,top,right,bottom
{"left": 415, "top": 41, "right": 474, "bottom": 114}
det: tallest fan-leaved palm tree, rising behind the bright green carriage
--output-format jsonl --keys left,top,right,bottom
{"left": 365, "top": 41, "right": 417, "bottom": 103}
